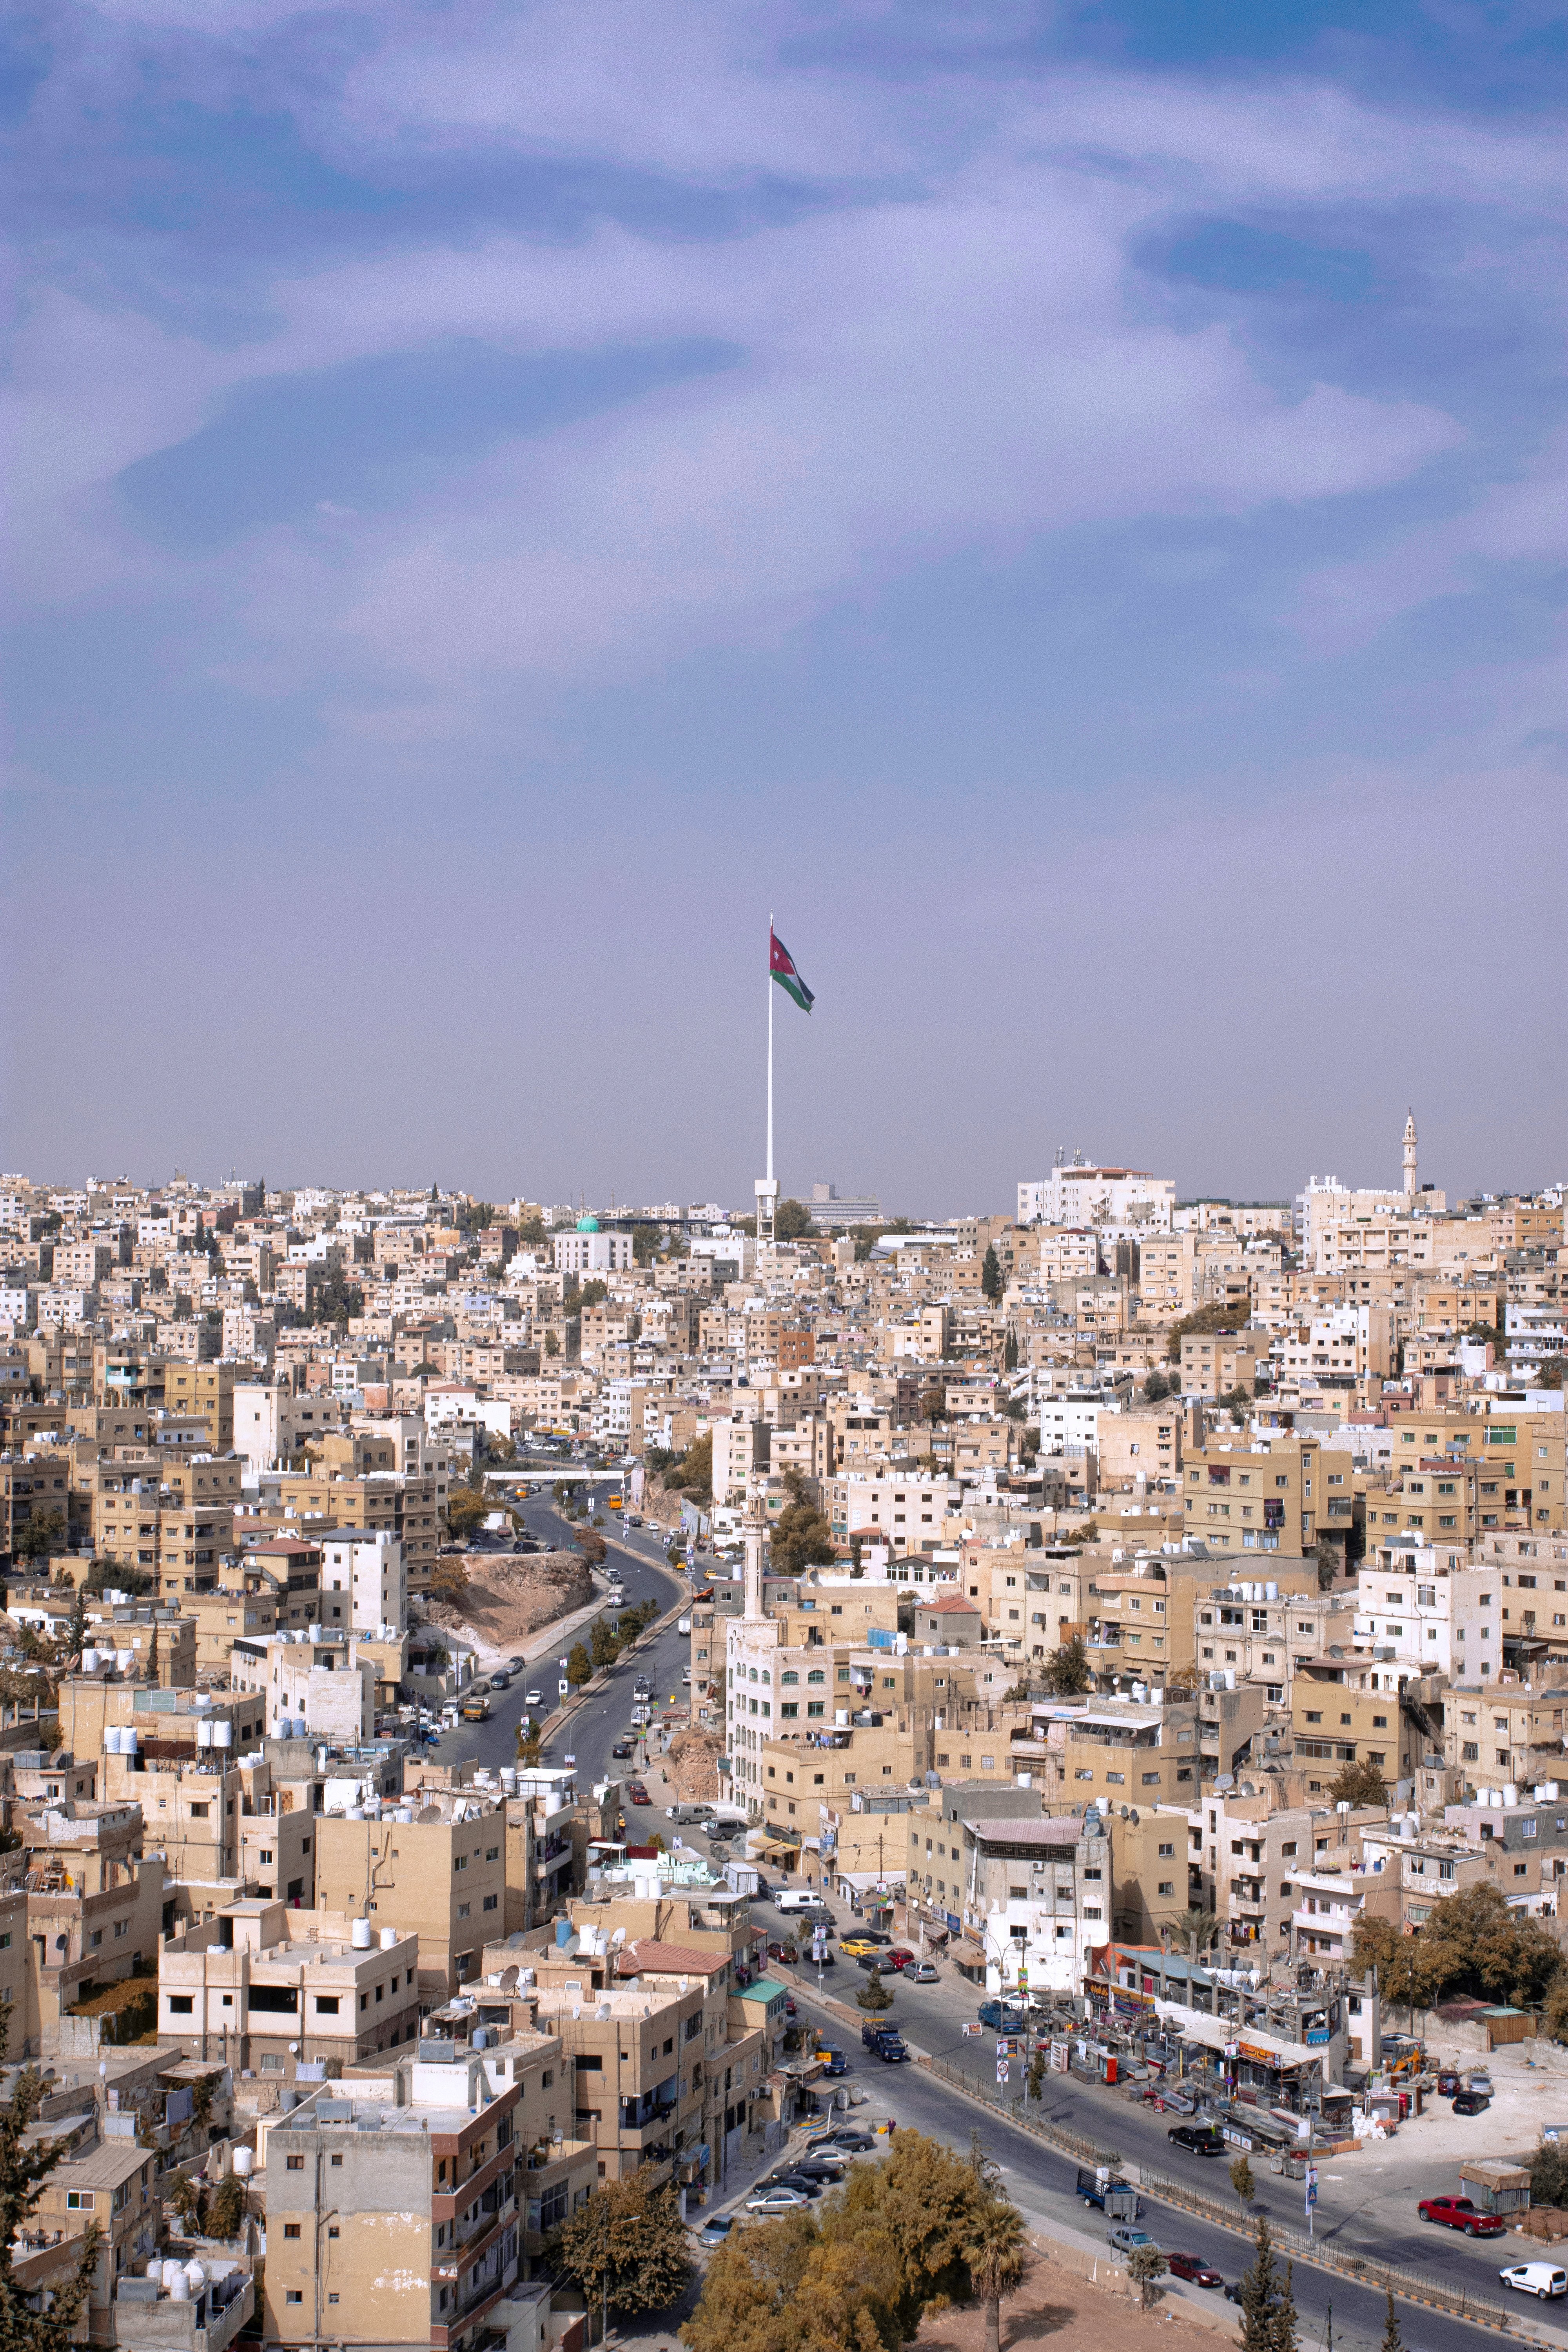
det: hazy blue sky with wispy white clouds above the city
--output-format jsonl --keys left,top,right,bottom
{"left": 0, "top": 0, "right": 1568, "bottom": 1214}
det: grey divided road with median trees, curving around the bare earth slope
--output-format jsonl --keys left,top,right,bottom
{"left": 435, "top": 1472, "right": 691, "bottom": 1820}
